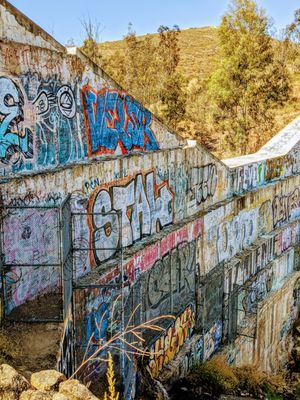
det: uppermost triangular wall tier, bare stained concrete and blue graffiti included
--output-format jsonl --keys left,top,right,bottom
{"left": 0, "top": 38, "right": 183, "bottom": 176}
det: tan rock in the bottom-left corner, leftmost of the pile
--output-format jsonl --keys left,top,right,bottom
{"left": 0, "top": 364, "right": 30, "bottom": 400}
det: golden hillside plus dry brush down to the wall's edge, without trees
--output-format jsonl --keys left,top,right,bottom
{"left": 95, "top": 27, "right": 300, "bottom": 158}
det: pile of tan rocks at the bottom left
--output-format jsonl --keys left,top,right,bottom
{"left": 0, "top": 364, "right": 99, "bottom": 400}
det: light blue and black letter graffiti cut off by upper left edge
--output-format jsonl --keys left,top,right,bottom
{"left": 0, "top": 76, "right": 33, "bottom": 164}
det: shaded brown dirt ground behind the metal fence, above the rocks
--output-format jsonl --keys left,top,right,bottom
{"left": 0, "top": 294, "right": 63, "bottom": 375}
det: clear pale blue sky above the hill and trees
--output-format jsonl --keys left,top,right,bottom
{"left": 10, "top": 0, "right": 300, "bottom": 45}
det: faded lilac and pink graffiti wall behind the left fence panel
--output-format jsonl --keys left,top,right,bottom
{"left": 2, "top": 208, "right": 61, "bottom": 314}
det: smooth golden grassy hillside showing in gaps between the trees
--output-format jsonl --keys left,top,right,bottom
{"left": 99, "top": 27, "right": 300, "bottom": 157}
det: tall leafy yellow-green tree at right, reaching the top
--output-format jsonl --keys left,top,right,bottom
{"left": 208, "top": 0, "right": 289, "bottom": 154}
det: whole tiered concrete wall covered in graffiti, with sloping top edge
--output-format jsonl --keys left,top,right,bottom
{"left": 0, "top": 0, "right": 300, "bottom": 398}
